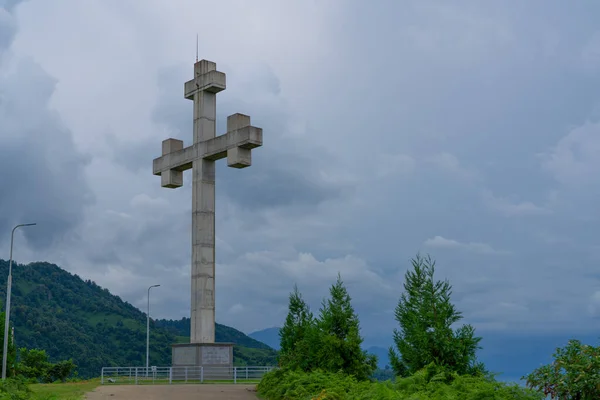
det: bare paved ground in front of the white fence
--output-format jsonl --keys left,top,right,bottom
{"left": 86, "top": 384, "right": 258, "bottom": 400}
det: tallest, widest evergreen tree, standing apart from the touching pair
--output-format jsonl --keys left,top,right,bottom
{"left": 389, "top": 254, "right": 486, "bottom": 377}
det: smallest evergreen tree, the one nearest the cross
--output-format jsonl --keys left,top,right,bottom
{"left": 279, "top": 285, "right": 316, "bottom": 371}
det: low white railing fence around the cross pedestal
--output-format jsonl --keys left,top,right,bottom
{"left": 101, "top": 367, "right": 275, "bottom": 385}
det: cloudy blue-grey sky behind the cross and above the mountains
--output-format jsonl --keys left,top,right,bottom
{"left": 0, "top": 0, "right": 600, "bottom": 382}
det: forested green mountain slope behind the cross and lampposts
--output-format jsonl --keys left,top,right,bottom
{"left": 0, "top": 260, "right": 277, "bottom": 377}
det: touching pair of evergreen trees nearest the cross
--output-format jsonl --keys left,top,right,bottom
{"left": 279, "top": 275, "right": 377, "bottom": 379}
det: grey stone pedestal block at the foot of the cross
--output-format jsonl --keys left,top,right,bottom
{"left": 171, "top": 343, "right": 233, "bottom": 379}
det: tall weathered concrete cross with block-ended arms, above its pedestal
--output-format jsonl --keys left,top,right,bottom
{"left": 153, "top": 60, "right": 262, "bottom": 343}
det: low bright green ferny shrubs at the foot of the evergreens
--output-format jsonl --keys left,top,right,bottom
{"left": 258, "top": 364, "right": 543, "bottom": 400}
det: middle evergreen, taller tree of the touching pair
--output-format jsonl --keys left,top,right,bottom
{"left": 317, "top": 274, "right": 377, "bottom": 379}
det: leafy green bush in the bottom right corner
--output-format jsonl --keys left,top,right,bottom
{"left": 521, "top": 340, "right": 600, "bottom": 400}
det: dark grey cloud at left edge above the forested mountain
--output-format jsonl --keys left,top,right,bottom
{"left": 0, "top": 1, "right": 93, "bottom": 247}
